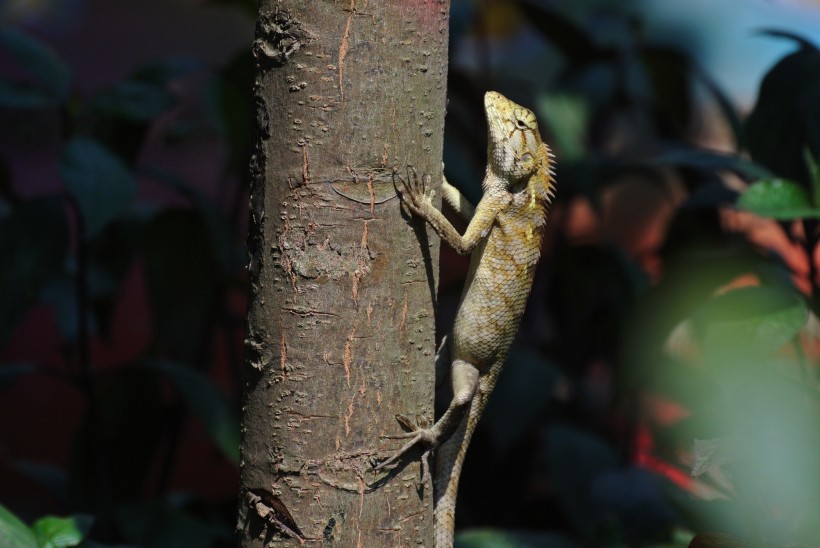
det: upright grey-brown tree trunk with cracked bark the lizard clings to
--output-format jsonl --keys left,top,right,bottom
{"left": 239, "top": 0, "right": 449, "bottom": 546}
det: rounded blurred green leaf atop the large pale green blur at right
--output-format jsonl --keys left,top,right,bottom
{"left": 693, "top": 286, "right": 808, "bottom": 359}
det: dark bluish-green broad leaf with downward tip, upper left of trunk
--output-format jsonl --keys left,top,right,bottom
{"left": 60, "top": 137, "right": 137, "bottom": 238}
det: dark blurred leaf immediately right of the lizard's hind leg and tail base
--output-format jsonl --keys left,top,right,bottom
{"left": 482, "top": 352, "right": 560, "bottom": 453}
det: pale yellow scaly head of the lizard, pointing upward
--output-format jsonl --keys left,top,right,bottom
{"left": 484, "top": 91, "right": 549, "bottom": 185}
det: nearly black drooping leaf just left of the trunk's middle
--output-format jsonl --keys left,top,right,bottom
{"left": 143, "top": 209, "right": 220, "bottom": 362}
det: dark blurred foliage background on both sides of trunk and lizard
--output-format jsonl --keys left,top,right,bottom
{"left": 0, "top": 0, "right": 820, "bottom": 546}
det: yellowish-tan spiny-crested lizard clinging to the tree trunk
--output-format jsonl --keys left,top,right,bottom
{"left": 377, "top": 91, "right": 556, "bottom": 548}
